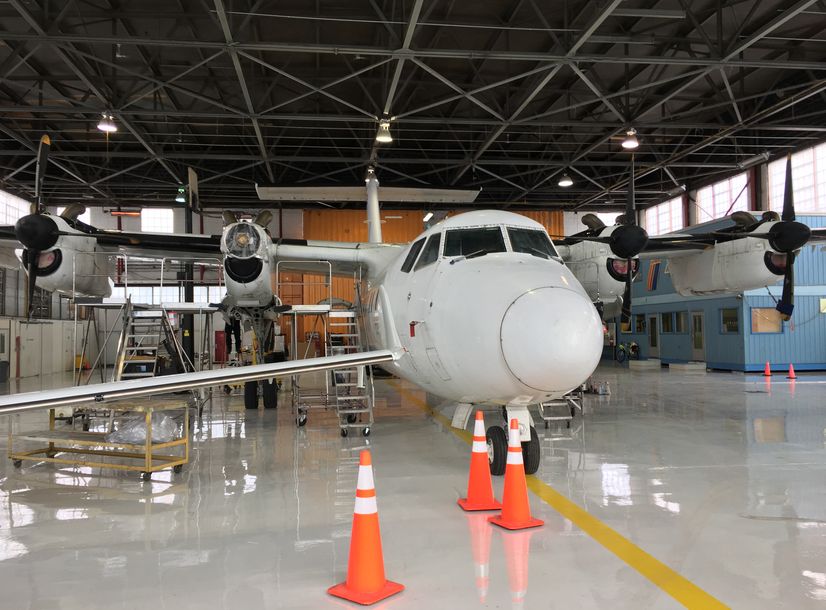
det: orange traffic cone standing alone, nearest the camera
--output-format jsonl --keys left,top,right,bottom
{"left": 327, "top": 449, "right": 404, "bottom": 606}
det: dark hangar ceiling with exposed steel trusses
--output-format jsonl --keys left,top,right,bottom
{"left": 0, "top": 0, "right": 826, "bottom": 210}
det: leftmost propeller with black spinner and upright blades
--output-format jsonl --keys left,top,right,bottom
{"left": 14, "top": 135, "right": 52, "bottom": 320}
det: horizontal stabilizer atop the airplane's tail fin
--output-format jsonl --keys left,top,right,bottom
{"left": 255, "top": 184, "right": 479, "bottom": 203}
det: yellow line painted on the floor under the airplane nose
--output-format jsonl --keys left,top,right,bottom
{"left": 390, "top": 381, "right": 728, "bottom": 609}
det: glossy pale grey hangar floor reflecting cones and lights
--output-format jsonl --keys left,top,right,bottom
{"left": 0, "top": 367, "right": 826, "bottom": 610}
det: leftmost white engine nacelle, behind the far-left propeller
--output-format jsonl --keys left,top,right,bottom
{"left": 23, "top": 216, "right": 113, "bottom": 297}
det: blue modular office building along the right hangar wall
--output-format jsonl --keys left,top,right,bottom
{"left": 617, "top": 215, "right": 826, "bottom": 371}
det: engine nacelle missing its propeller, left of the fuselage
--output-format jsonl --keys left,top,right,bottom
{"left": 221, "top": 222, "right": 274, "bottom": 307}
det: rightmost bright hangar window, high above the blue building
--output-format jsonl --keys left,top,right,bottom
{"left": 768, "top": 144, "right": 826, "bottom": 214}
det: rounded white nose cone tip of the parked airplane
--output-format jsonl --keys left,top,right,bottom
{"left": 500, "top": 288, "right": 602, "bottom": 392}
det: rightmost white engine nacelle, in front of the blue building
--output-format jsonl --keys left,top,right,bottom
{"left": 668, "top": 237, "right": 785, "bottom": 296}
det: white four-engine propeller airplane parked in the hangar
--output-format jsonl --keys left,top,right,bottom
{"left": 0, "top": 140, "right": 824, "bottom": 474}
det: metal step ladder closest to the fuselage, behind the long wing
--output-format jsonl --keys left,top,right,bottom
{"left": 328, "top": 309, "right": 375, "bottom": 436}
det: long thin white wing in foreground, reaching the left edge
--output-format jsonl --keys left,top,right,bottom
{"left": 0, "top": 350, "right": 395, "bottom": 415}
